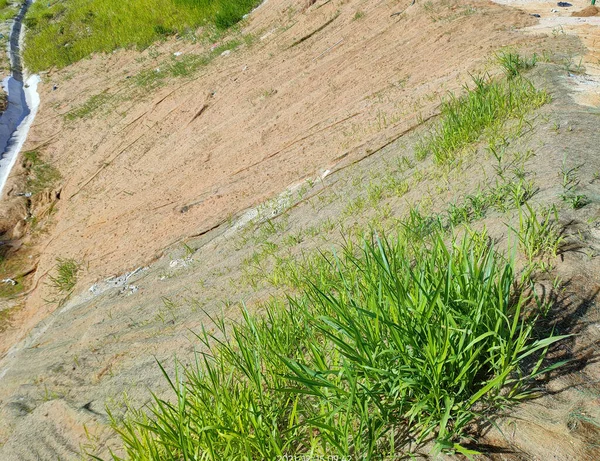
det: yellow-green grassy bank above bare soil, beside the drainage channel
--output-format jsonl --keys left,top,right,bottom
{"left": 24, "top": 0, "right": 258, "bottom": 72}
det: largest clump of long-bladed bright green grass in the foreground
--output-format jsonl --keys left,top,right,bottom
{"left": 105, "top": 226, "right": 561, "bottom": 460}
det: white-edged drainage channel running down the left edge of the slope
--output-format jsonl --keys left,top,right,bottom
{"left": 0, "top": 0, "right": 39, "bottom": 194}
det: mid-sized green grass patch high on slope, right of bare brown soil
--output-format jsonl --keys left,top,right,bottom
{"left": 415, "top": 75, "right": 550, "bottom": 163}
